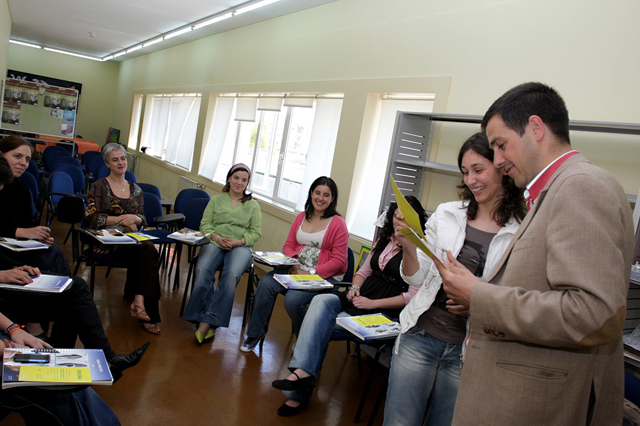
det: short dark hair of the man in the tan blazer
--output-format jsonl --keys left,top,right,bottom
{"left": 481, "top": 82, "right": 570, "bottom": 144}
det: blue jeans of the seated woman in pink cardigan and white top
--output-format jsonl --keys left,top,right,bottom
{"left": 247, "top": 269, "right": 332, "bottom": 337}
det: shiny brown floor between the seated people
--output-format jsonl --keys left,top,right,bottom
{"left": 2, "top": 221, "right": 382, "bottom": 426}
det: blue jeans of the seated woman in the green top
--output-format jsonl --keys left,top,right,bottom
{"left": 183, "top": 244, "right": 251, "bottom": 327}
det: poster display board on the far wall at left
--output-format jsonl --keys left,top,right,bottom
{"left": 0, "top": 70, "right": 82, "bottom": 139}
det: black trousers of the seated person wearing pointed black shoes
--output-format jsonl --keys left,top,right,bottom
{"left": 0, "top": 277, "right": 115, "bottom": 360}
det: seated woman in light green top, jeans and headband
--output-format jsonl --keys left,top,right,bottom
{"left": 183, "top": 163, "right": 262, "bottom": 343}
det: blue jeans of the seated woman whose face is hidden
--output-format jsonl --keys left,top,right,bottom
{"left": 283, "top": 294, "right": 353, "bottom": 402}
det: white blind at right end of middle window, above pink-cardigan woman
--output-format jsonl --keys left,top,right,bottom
{"left": 296, "top": 99, "right": 342, "bottom": 211}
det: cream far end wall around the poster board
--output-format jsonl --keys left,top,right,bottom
{"left": 7, "top": 44, "right": 120, "bottom": 145}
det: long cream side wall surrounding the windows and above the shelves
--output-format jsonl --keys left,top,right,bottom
{"left": 107, "top": 0, "right": 640, "bottom": 248}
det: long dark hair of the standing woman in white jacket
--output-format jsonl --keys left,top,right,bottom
{"left": 458, "top": 132, "right": 527, "bottom": 226}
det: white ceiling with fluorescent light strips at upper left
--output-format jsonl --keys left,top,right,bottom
{"left": 8, "top": 0, "right": 335, "bottom": 61}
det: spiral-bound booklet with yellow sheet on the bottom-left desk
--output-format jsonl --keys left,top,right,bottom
{"left": 2, "top": 348, "right": 113, "bottom": 389}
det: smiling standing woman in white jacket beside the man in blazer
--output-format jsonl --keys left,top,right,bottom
{"left": 384, "top": 133, "right": 526, "bottom": 426}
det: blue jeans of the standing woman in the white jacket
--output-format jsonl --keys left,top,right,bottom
{"left": 384, "top": 326, "right": 462, "bottom": 426}
